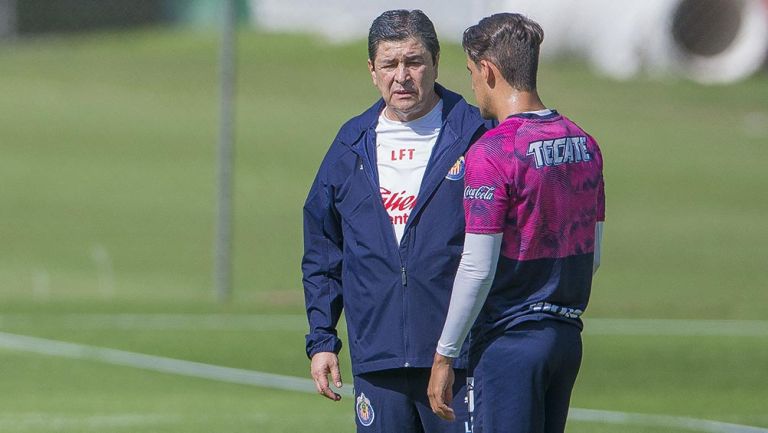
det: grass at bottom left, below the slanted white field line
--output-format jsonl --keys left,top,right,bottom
{"left": 0, "top": 354, "right": 351, "bottom": 433}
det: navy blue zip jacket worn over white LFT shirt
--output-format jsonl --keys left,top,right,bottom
{"left": 302, "top": 84, "right": 491, "bottom": 374}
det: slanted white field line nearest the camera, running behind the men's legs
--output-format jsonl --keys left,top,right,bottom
{"left": 0, "top": 332, "right": 768, "bottom": 433}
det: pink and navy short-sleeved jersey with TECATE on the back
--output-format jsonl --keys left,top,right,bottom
{"left": 464, "top": 111, "right": 605, "bottom": 346}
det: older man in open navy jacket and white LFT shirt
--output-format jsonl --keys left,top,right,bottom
{"left": 302, "top": 10, "right": 486, "bottom": 433}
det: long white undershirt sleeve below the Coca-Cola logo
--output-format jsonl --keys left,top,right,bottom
{"left": 437, "top": 233, "right": 502, "bottom": 358}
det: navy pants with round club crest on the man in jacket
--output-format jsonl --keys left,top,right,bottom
{"left": 354, "top": 368, "right": 469, "bottom": 433}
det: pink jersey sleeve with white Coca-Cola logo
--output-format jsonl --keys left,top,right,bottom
{"left": 464, "top": 139, "right": 510, "bottom": 234}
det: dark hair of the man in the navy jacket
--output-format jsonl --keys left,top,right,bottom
{"left": 368, "top": 9, "right": 440, "bottom": 64}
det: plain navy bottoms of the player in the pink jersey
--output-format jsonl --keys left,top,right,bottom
{"left": 470, "top": 320, "right": 582, "bottom": 433}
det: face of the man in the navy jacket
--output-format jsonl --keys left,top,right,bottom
{"left": 368, "top": 38, "right": 437, "bottom": 121}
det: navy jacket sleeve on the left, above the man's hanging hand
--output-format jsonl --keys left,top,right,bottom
{"left": 301, "top": 151, "right": 343, "bottom": 358}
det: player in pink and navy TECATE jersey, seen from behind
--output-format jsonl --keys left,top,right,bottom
{"left": 428, "top": 13, "right": 604, "bottom": 433}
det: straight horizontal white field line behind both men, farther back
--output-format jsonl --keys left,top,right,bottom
{"left": 0, "top": 314, "right": 768, "bottom": 337}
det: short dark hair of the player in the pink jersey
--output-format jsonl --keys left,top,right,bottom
{"left": 462, "top": 13, "right": 544, "bottom": 91}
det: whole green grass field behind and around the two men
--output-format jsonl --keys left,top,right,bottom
{"left": 0, "top": 30, "right": 768, "bottom": 433}
